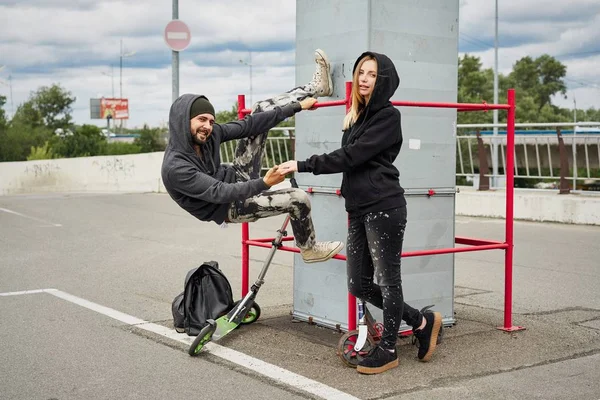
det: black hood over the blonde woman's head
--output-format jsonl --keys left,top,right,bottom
{"left": 352, "top": 51, "right": 400, "bottom": 113}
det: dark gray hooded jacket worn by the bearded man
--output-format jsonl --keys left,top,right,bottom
{"left": 161, "top": 94, "right": 301, "bottom": 224}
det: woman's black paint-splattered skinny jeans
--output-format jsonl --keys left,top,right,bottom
{"left": 346, "top": 206, "right": 422, "bottom": 349}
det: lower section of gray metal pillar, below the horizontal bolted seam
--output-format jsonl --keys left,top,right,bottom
{"left": 293, "top": 194, "right": 454, "bottom": 330}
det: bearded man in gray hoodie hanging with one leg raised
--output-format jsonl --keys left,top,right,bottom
{"left": 161, "top": 49, "right": 344, "bottom": 263}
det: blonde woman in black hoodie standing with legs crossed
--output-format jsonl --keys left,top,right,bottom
{"left": 279, "top": 52, "right": 442, "bottom": 374}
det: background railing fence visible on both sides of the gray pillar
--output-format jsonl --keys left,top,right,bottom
{"left": 221, "top": 122, "right": 600, "bottom": 190}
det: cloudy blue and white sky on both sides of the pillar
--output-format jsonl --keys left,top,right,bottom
{"left": 0, "top": 0, "right": 600, "bottom": 127}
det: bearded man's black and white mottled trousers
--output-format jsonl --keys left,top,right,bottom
{"left": 228, "top": 86, "right": 315, "bottom": 249}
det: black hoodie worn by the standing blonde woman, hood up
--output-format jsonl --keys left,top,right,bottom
{"left": 298, "top": 52, "right": 406, "bottom": 214}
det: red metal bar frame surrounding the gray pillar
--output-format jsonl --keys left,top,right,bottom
{"left": 238, "top": 82, "right": 525, "bottom": 332}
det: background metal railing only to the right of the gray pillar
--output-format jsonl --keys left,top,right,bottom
{"left": 456, "top": 122, "right": 600, "bottom": 190}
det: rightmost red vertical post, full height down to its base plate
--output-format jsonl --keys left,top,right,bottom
{"left": 501, "top": 89, "right": 524, "bottom": 331}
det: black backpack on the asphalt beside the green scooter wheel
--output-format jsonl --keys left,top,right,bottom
{"left": 171, "top": 261, "right": 234, "bottom": 336}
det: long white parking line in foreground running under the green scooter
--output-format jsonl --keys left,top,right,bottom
{"left": 0, "top": 289, "right": 359, "bottom": 400}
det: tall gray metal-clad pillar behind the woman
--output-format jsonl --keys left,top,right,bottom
{"left": 293, "top": 0, "right": 459, "bottom": 328}
